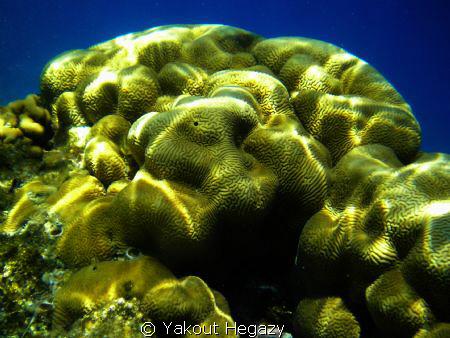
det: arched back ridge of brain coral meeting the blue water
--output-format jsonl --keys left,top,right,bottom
{"left": 41, "top": 25, "right": 420, "bottom": 162}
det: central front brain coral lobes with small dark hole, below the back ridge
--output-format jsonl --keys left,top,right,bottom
{"left": 55, "top": 81, "right": 329, "bottom": 265}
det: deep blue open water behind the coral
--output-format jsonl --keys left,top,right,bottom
{"left": 0, "top": 0, "right": 450, "bottom": 153}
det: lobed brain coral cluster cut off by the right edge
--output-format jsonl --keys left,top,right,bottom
{"left": 297, "top": 145, "right": 450, "bottom": 336}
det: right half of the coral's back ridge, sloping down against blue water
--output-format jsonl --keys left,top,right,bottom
{"left": 253, "top": 38, "right": 420, "bottom": 162}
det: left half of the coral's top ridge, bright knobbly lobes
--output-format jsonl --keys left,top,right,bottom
{"left": 41, "top": 25, "right": 258, "bottom": 127}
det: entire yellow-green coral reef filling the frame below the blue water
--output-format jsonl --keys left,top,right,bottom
{"left": 0, "top": 25, "right": 450, "bottom": 337}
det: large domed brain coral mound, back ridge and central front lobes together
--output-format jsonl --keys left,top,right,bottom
{"left": 37, "top": 25, "right": 420, "bottom": 272}
